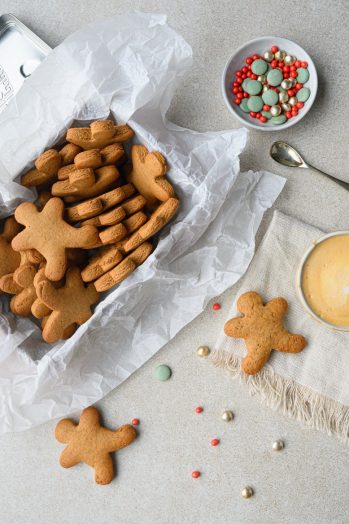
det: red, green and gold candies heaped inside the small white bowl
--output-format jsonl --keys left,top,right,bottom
{"left": 230, "top": 45, "right": 310, "bottom": 125}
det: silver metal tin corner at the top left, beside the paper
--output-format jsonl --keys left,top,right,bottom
{"left": 0, "top": 14, "right": 51, "bottom": 112}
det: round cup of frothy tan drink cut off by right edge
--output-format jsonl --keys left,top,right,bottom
{"left": 297, "top": 231, "right": 349, "bottom": 331}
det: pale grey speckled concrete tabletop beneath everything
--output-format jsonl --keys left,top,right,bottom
{"left": 0, "top": 0, "right": 349, "bottom": 524}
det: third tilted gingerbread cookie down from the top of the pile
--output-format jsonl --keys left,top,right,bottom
{"left": 52, "top": 166, "right": 120, "bottom": 202}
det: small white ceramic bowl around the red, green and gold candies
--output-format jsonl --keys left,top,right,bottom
{"left": 222, "top": 36, "right": 318, "bottom": 131}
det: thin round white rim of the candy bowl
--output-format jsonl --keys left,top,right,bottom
{"left": 221, "top": 35, "right": 318, "bottom": 132}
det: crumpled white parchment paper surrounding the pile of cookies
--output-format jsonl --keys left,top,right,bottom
{"left": 0, "top": 13, "right": 284, "bottom": 432}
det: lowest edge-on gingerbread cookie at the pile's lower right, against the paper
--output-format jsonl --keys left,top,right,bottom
{"left": 94, "top": 242, "right": 153, "bottom": 291}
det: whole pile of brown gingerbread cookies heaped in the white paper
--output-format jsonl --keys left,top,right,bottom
{"left": 0, "top": 120, "right": 179, "bottom": 343}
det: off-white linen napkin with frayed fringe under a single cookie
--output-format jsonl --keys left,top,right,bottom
{"left": 211, "top": 211, "right": 349, "bottom": 443}
